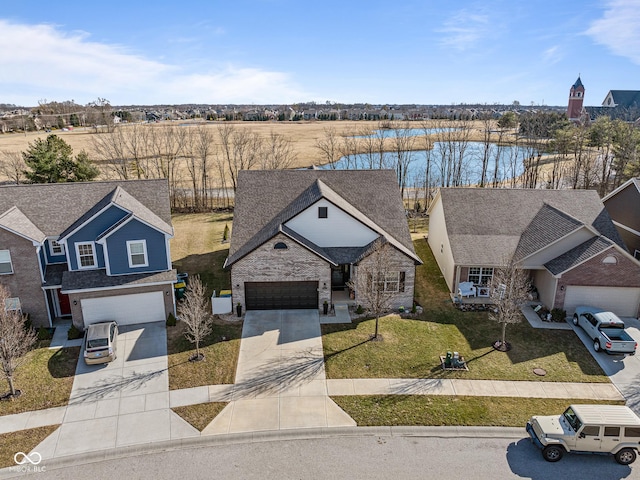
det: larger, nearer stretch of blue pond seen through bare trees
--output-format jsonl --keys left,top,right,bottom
{"left": 322, "top": 142, "right": 537, "bottom": 186}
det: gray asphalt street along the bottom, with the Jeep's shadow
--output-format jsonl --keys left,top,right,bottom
{"left": 13, "top": 435, "right": 640, "bottom": 480}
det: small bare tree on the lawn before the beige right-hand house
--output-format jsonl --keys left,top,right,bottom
{"left": 489, "top": 257, "right": 530, "bottom": 350}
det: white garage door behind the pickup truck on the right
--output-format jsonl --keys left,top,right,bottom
{"left": 564, "top": 286, "right": 640, "bottom": 317}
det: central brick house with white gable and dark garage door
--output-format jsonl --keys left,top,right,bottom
{"left": 225, "top": 170, "right": 421, "bottom": 310}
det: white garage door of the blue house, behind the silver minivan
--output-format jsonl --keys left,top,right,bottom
{"left": 80, "top": 292, "right": 166, "bottom": 325}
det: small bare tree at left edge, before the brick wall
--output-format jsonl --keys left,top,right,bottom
{"left": 0, "top": 285, "right": 36, "bottom": 398}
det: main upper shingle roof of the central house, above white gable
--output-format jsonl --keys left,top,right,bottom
{"left": 226, "top": 170, "right": 420, "bottom": 266}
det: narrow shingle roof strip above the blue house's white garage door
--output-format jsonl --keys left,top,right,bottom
{"left": 62, "top": 269, "right": 177, "bottom": 293}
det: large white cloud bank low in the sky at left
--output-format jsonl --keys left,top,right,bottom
{"left": 0, "top": 20, "right": 306, "bottom": 105}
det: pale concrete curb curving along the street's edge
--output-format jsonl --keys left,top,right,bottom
{"left": 0, "top": 426, "right": 527, "bottom": 478}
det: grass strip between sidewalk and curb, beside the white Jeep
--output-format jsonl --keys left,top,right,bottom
{"left": 331, "top": 395, "right": 623, "bottom": 428}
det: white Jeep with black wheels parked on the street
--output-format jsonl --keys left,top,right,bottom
{"left": 526, "top": 405, "right": 640, "bottom": 465}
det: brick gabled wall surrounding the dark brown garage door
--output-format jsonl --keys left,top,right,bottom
{"left": 231, "top": 234, "right": 331, "bottom": 310}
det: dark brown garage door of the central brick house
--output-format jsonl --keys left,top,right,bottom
{"left": 244, "top": 282, "right": 318, "bottom": 310}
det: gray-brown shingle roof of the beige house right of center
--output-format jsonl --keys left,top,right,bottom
{"left": 440, "top": 188, "right": 624, "bottom": 266}
